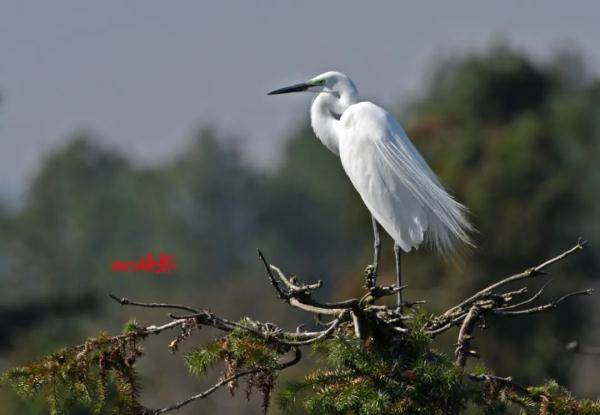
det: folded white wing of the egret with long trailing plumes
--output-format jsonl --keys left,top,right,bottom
{"left": 340, "top": 102, "right": 471, "bottom": 253}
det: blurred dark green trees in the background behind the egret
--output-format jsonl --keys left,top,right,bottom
{"left": 0, "top": 45, "right": 600, "bottom": 414}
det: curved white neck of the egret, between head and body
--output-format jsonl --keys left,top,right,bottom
{"left": 310, "top": 82, "right": 358, "bottom": 156}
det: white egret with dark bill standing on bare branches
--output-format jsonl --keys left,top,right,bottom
{"left": 269, "top": 72, "right": 472, "bottom": 308}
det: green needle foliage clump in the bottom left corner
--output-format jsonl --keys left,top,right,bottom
{"left": 2, "top": 333, "right": 143, "bottom": 415}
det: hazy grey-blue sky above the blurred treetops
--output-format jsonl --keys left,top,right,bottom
{"left": 0, "top": 0, "right": 600, "bottom": 200}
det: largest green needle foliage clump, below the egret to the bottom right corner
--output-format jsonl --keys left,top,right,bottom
{"left": 278, "top": 316, "right": 600, "bottom": 415}
